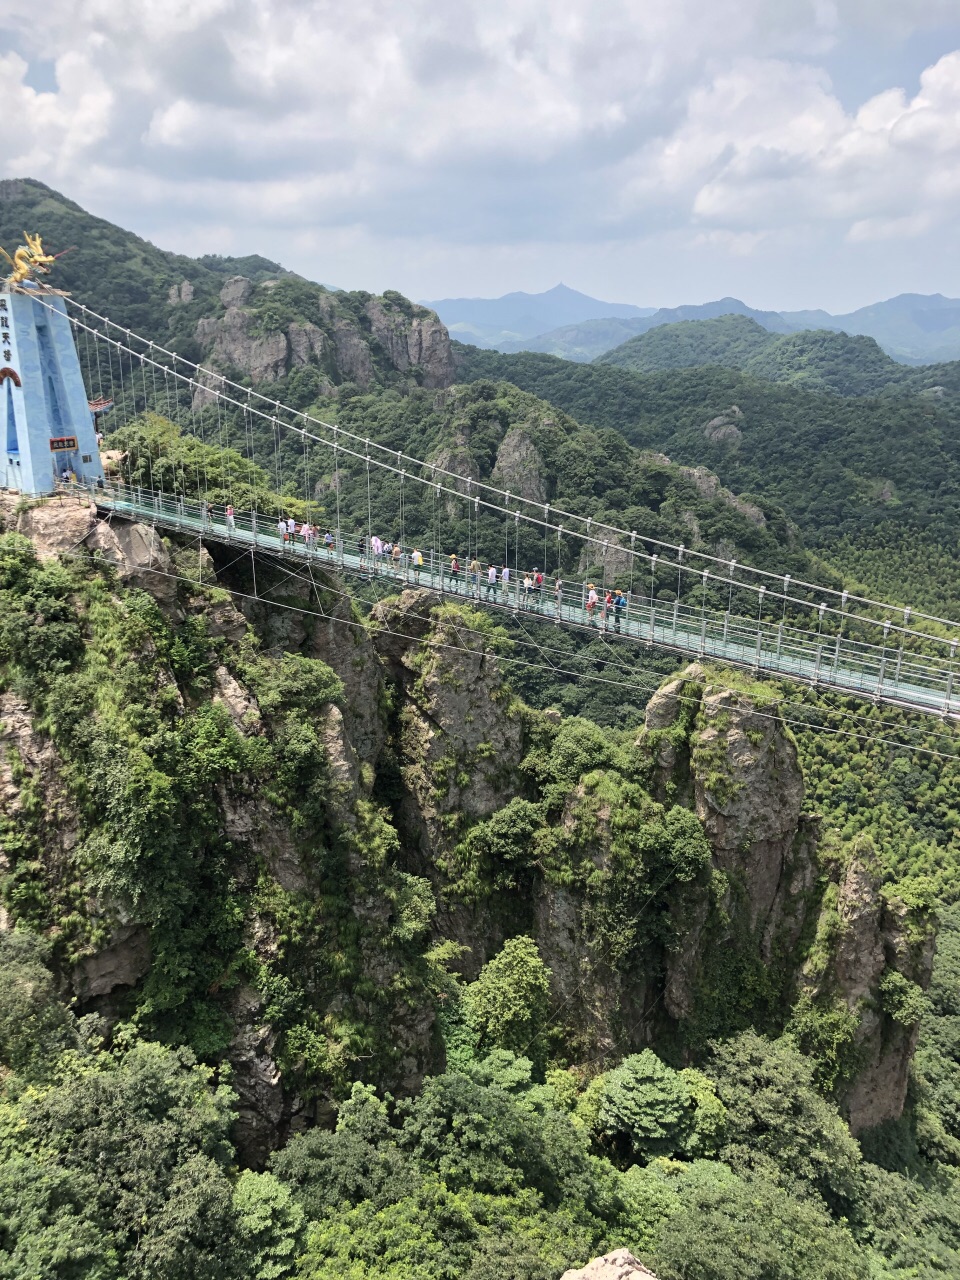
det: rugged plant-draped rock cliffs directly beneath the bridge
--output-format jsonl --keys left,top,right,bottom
{"left": 0, "top": 507, "right": 932, "bottom": 1165}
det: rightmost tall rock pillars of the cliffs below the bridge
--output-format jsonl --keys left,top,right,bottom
{"left": 639, "top": 666, "right": 936, "bottom": 1132}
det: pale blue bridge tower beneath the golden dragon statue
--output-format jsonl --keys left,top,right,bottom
{"left": 0, "top": 282, "right": 104, "bottom": 497}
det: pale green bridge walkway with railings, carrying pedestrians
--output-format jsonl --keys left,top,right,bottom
{"left": 69, "top": 483, "right": 960, "bottom": 716}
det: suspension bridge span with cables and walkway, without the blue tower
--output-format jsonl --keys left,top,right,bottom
{"left": 16, "top": 294, "right": 960, "bottom": 719}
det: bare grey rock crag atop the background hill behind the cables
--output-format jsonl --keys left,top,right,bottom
{"left": 196, "top": 276, "right": 453, "bottom": 403}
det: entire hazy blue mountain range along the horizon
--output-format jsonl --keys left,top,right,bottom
{"left": 437, "top": 284, "right": 960, "bottom": 365}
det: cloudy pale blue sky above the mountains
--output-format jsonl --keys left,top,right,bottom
{"left": 0, "top": 0, "right": 960, "bottom": 312}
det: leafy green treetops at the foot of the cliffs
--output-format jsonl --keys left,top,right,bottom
{"left": 0, "top": 938, "right": 960, "bottom": 1280}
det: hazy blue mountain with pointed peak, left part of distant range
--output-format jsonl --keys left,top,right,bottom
{"left": 422, "top": 284, "right": 657, "bottom": 348}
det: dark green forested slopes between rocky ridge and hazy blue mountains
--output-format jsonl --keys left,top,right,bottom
{"left": 457, "top": 348, "right": 960, "bottom": 616}
